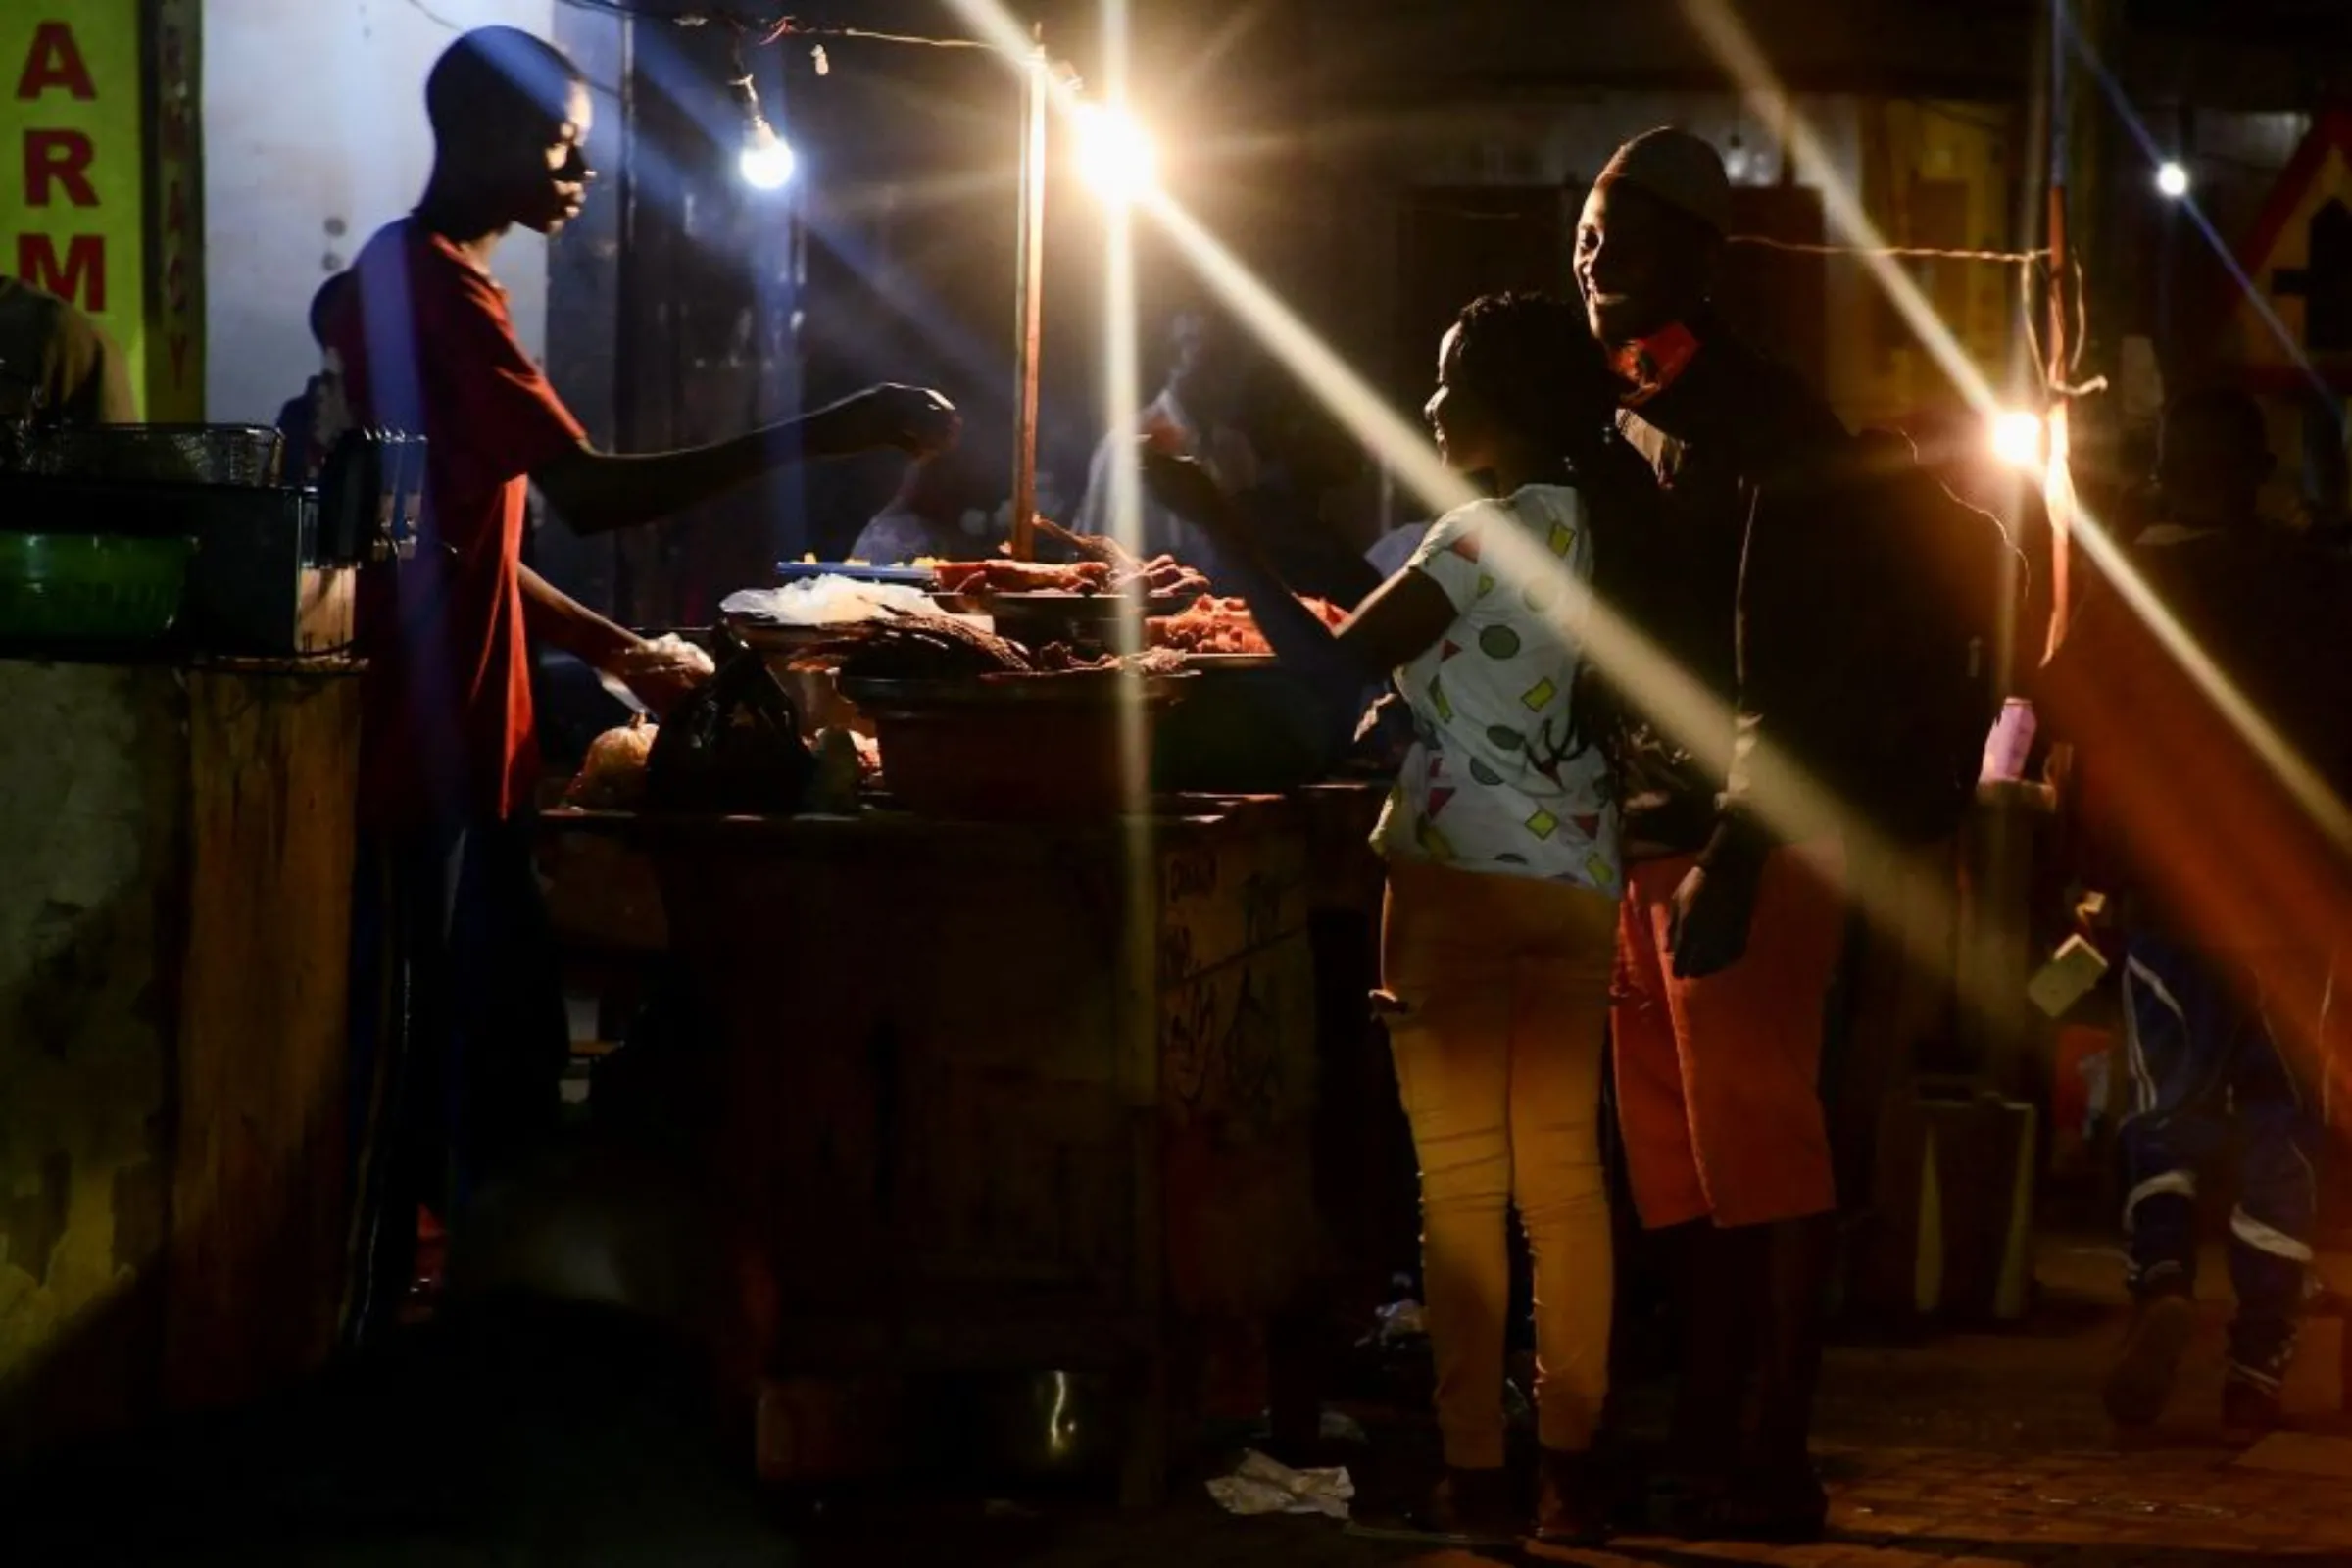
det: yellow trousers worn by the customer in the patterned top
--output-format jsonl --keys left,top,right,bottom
{"left": 1381, "top": 860, "right": 1618, "bottom": 1469}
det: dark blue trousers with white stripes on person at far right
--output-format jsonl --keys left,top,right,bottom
{"left": 2119, "top": 931, "right": 2319, "bottom": 1390}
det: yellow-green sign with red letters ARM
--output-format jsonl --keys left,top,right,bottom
{"left": 0, "top": 0, "right": 151, "bottom": 416}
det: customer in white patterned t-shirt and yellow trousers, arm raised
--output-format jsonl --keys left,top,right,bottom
{"left": 1146, "top": 294, "right": 1623, "bottom": 1543}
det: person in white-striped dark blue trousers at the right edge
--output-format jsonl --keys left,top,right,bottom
{"left": 2046, "top": 390, "right": 2352, "bottom": 1441}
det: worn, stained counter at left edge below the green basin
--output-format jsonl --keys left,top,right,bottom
{"left": 0, "top": 661, "right": 358, "bottom": 1455}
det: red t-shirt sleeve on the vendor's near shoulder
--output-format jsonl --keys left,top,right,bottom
{"left": 428, "top": 268, "right": 586, "bottom": 550}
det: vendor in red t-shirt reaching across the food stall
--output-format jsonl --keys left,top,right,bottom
{"left": 324, "top": 28, "right": 955, "bottom": 1331}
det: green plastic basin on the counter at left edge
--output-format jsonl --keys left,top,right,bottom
{"left": 0, "top": 534, "right": 195, "bottom": 642}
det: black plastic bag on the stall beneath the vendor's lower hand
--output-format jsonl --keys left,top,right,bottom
{"left": 645, "top": 632, "right": 816, "bottom": 815}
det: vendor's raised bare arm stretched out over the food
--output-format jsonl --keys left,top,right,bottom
{"left": 531, "top": 385, "right": 957, "bottom": 534}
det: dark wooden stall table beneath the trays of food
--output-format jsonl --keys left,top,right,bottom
{"left": 548, "top": 790, "right": 1364, "bottom": 1493}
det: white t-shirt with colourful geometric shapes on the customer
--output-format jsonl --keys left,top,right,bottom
{"left": 1374, "top": 484, "right": 1625, "bottom": 896}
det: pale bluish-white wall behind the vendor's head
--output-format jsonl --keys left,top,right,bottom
{"left": 205, "top": 0, "right": 555, "bottom": 423}
